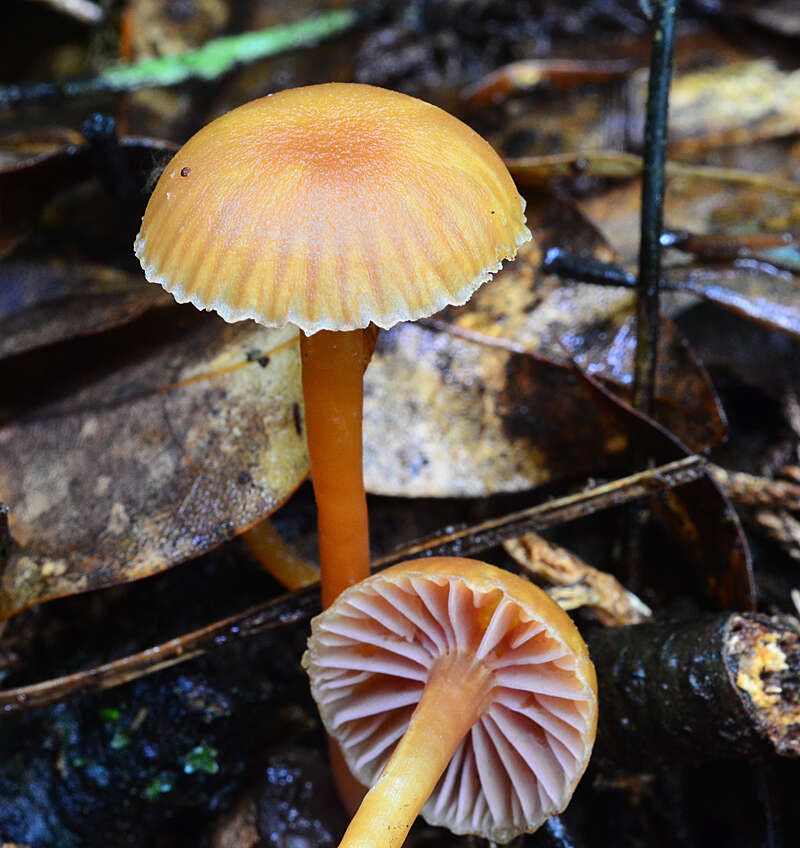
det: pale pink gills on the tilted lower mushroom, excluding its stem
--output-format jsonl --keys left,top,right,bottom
{"left": 306, "top": 574, "right": 593, "bottom": 842}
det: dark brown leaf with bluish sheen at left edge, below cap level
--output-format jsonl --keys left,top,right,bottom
{"left": 0, "top": 261, "right": 164, "bottom": 358}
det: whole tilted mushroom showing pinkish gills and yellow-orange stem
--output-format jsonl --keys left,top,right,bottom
{"left": 303, "top": 557, "right": 597, "bottom": 848}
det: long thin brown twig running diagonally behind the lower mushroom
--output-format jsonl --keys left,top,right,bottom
{"left": 0, "top": 456, "right": 705, "bottom": 714}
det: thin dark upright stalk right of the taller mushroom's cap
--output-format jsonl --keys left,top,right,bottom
{"left": 633, "top": 0, "right": 678, "bottom": 415}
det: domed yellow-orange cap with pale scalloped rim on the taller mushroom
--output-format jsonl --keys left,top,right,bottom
{"left": 134, "top": 83, "right": 530, "bottom": 333}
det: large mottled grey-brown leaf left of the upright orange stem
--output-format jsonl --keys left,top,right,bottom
{"left": 0, "top": 310, "right": 308, "bottom": 617}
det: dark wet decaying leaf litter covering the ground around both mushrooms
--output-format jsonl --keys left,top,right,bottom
{"left": 0, "top": 2, "right": 800, "bottom": 845}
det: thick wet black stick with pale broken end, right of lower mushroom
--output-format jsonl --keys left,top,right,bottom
{"left": 586, "top": 613, "right": 800, "bottom": 770}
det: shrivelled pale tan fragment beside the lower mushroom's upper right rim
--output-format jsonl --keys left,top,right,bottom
{"left": 503, "top": 533, "right": 653, "bottom": 627}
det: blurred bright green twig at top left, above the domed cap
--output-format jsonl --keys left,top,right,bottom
{"left": 0, "top": 9, "right": 361, "bottom": 109}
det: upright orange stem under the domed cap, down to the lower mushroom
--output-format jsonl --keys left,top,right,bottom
{"left": 300, "top": 330, "right": 372, "bottom": 608}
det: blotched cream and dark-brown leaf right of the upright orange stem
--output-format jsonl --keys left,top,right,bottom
{"left": 364, "top": 195, "right": 724, "bottom": 496}
